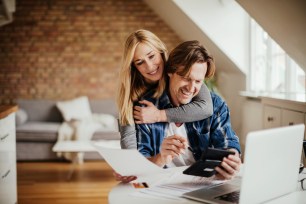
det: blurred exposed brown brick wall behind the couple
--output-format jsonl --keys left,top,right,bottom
{"left": 0, "top": 0, "right": 181, "bottom": 104}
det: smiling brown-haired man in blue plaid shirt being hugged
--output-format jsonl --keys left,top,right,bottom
{"left": 136, "top": 41, "right": 241, "bottom": 179}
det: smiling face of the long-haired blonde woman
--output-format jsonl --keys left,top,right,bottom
{"left": 133, "top": 43, "right": 164, "bottom": 83}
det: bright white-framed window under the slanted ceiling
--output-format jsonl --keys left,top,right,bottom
{"left": 248, "top": 19, "right": 306, "bottom": 100}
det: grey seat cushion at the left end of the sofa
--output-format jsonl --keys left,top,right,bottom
{"left": 16, "top": 122, "right": 61, "bottom": 142}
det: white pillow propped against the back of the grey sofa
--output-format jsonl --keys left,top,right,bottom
{"left": 56, "top": 96, "right": 91, "bottom": 121}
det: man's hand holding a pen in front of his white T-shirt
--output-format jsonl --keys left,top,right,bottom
{"left": 149, "top": 135, "right": 188, "bottom": 166}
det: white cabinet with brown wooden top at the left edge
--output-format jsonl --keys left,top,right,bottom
{"left": 0, "top": 106, "right": 17, "bottom": 204}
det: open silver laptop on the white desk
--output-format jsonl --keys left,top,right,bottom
{"left": 183, "top": 124, "right": 305, "bottom": 204}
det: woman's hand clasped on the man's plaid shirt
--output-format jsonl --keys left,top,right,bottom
{"left": 133, "top": 100, "right": 167, "bottom": 124}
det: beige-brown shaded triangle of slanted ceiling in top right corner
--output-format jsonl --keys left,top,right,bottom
{"left": 236, "top": 0, "right": 306, "bottom": 71}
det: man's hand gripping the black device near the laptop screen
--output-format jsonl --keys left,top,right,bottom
{"left": 216, "top": 149, "right": 241, "bottom": 180}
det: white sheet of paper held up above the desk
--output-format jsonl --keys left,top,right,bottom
{"left": 94, "top": 145, "right": 165, "bottom": 178}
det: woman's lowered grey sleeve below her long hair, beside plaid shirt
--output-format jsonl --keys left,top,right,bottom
{"left": 119, "top": 125, "right": 137, "bottom": 149}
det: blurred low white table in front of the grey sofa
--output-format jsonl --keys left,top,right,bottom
{"left": 52, "top": 140, "right": 121, "bottom": 180}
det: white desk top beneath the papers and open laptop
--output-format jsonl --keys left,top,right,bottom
{"left": 108, "top": 168, "right": 306, "bottom": 204}
